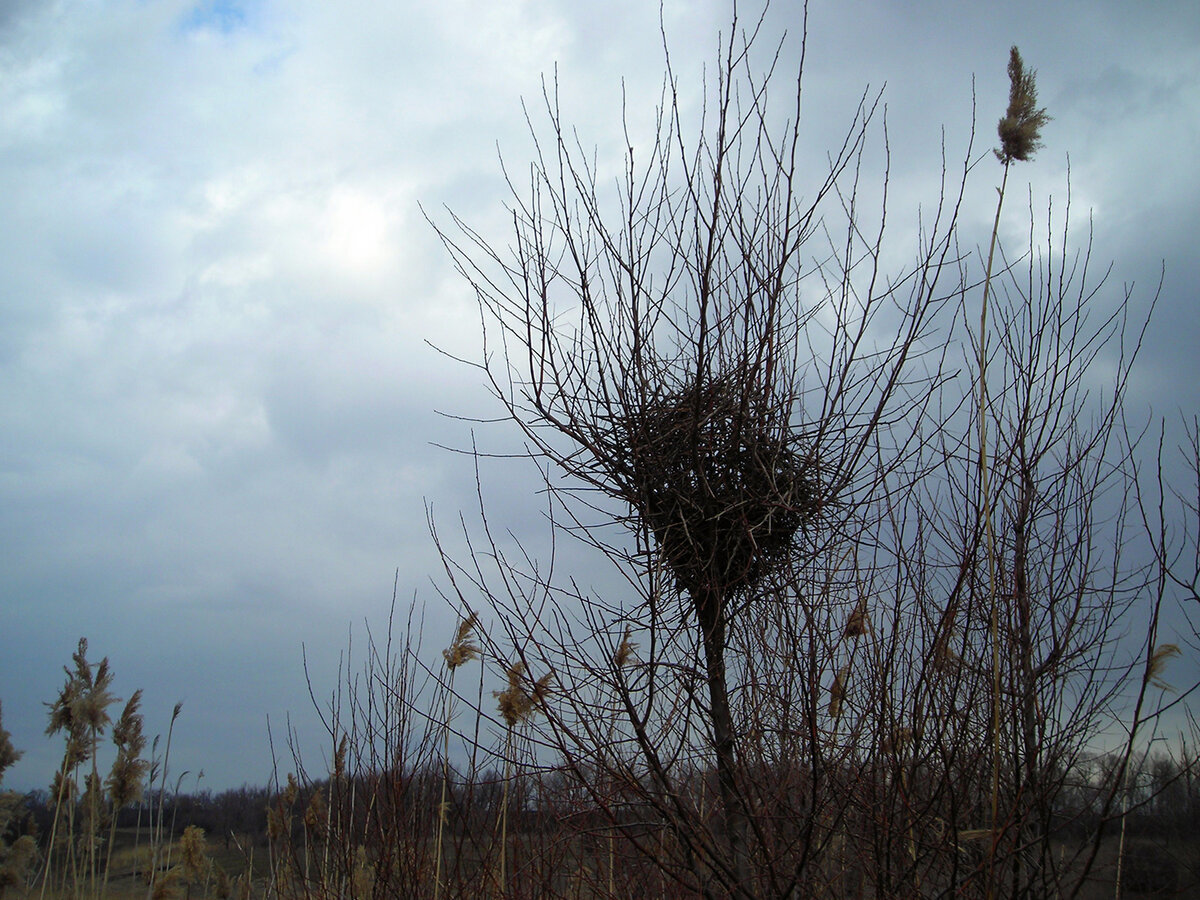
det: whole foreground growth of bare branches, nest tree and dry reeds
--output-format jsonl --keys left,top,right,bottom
{"left": 0, "top": 7, "right": 1200, "bottom": 900}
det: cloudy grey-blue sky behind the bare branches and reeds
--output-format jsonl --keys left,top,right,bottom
{"left": 0, "top": 0, "right": 1200, "bottom": 790}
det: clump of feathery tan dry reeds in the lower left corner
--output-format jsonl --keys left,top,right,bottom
{"left": 0, "top": 638, "right": 262, "bottom": 900}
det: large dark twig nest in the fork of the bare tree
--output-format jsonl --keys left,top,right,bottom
{"left": 622, "top": 382, "right": 818, "bottom": 611}
